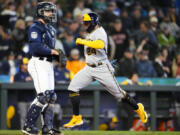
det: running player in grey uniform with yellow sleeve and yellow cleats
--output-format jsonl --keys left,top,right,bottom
{"left": 64, "top": 13, "right": 148, "bottom": 128}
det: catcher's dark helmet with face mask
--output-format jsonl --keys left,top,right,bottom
{"left": 36, "top": 2, "right": 57, "bottom": 23}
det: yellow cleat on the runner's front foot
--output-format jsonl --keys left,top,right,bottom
{"left": 64, "top": 115, "right": 83, "bottom": 128}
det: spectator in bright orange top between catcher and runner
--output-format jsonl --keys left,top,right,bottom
{"left": 66, "top": 49, "right": 86, "bottom": 75}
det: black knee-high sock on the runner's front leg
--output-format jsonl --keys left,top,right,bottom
{"left": 69, "top": 91, "right": 80, "bottom": 115}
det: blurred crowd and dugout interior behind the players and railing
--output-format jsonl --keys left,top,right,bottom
{"left": 0, "top": 0, "right": 180, "bottom": 131}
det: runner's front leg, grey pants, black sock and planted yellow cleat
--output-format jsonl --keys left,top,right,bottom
{"left": 64, "top": 67, "right": 92, "bottom": 128}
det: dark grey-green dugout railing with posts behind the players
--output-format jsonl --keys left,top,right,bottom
{"left": 0, "top": 83, "right": 180, "bottom": 131}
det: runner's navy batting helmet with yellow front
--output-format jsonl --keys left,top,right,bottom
{"left": 83, "top": 13, "right": 99, "bottom": 32}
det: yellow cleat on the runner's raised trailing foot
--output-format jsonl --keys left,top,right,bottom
{"left": 135, "top": 103, "right": 148, "bottom": 123}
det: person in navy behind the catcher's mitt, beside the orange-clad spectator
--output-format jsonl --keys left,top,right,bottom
{"left": 54, "top": 62, "right": 71, "bottom": 84}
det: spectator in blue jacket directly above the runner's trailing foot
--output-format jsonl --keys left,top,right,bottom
{"left": 136, "top": 50, "right": 157, "bottom": 77}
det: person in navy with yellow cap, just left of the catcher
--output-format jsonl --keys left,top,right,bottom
{"left": 14, "top": 58, "right": 32, "bottom": 82}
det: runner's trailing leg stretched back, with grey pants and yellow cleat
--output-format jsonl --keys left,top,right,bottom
{"left": 96, "top": 64, "right": 148, "bottom": 123}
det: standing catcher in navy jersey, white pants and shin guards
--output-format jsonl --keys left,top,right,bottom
{"left": 22, "top": 2, "right": 61, "bottom": 135}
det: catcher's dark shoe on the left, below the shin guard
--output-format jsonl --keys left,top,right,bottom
{"left": 21, "top": 127, "right": 40, "bottom": 135}
